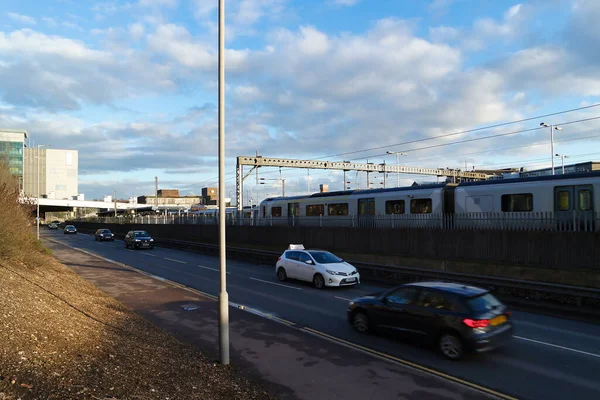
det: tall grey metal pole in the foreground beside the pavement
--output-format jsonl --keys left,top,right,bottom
{"left": 219, "top": 0, "right": 229, "bottom": 365}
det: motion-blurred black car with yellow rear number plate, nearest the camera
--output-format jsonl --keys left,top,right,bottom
{"left": 348, "top": 282, "right": 513, "bottom": 360}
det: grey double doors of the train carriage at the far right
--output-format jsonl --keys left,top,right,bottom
{"left": 554, "top": 185, "right": 595, "bottom": 231}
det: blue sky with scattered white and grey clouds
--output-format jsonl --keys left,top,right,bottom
{"left": 0, "top": 0, "right": 600, "bottom": 205}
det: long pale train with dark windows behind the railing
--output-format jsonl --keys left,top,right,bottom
{"left": 257, "top": 171, "right": 600, "bottom": 230}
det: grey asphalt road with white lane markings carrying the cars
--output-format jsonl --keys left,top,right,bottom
{"left": 43, "top": 231, "right": 600, "bottom": 399}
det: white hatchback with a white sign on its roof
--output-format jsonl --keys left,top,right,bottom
{"left": 275, "top": 245, "right": 360, "bottom": 289}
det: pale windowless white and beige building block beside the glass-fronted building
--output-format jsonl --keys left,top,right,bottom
{"left": 23, "top": 147, "right": 80, "bottom": 200}
